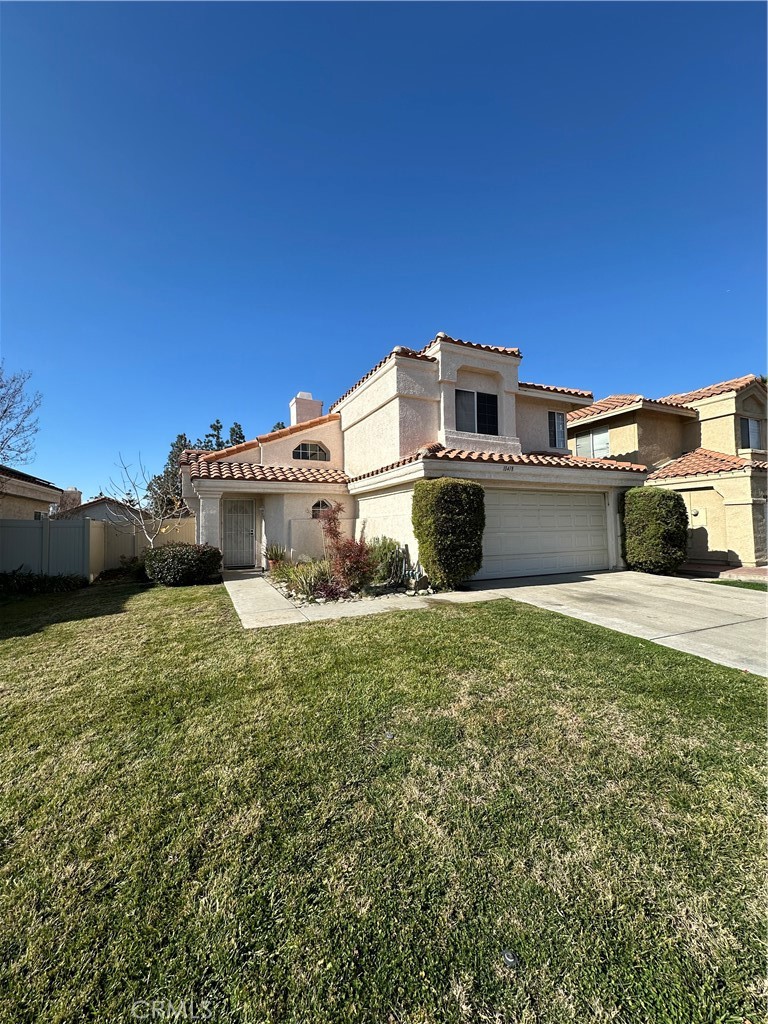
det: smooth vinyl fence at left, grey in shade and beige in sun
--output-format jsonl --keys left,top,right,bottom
{"left": 0, "top": 518, "right": 195, "bottom": 582}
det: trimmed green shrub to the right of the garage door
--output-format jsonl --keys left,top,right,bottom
{"left": 624, "top": 487, "right": 688, "bottom": 573}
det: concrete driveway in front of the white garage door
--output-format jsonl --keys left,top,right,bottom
{"left": 457, "top": 572, "right": 768, "bottom": 676}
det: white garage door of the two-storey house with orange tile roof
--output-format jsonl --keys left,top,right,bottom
{"left": 475, "top": 490, "right": 608, "bottom": 580}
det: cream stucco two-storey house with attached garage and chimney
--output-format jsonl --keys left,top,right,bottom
{"left": 181, "top": 334, "right": 645, "bottom": 579}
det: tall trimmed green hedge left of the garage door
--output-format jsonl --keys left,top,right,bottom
{"left": 412, "top": 477, "right": 485, "bottom": 588}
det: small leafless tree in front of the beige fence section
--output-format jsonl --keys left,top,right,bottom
{"left": 102, "top": 455, "right": 187, "bottom": 548}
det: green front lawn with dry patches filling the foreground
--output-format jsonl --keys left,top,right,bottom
{"left": 0, "top": 585, "right": 765, "bottom": 1024}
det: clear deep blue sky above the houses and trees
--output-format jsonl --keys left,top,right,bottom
{"left": 0, "top": 3, "right": 766, "bottom": 498}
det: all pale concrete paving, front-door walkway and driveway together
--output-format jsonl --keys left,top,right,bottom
{"left": 223, "top": 571, "right": 768, "bottom": 675}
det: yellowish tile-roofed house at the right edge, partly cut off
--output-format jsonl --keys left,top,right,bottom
{"left": 568, "top": 374, "right": 768, "bottom": 565}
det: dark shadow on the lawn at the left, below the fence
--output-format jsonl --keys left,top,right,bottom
{"left": 0, "top": 581, "right": 147, "bottom": 640}
